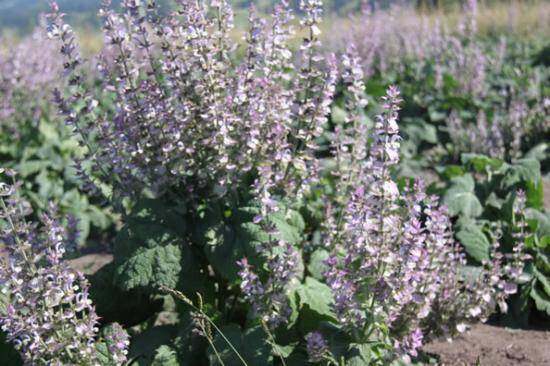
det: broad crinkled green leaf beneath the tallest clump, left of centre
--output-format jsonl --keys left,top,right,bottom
{"left": 115, "top": 245, "right": 182, "bottom": 290}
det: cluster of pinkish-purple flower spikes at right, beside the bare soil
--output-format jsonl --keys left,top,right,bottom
{"left": 325, "top": 87, "right": 521, "bottom": 356}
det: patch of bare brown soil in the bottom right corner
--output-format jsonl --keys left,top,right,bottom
{"left": 424, "top": 324, "right": 550, "bottom": 366}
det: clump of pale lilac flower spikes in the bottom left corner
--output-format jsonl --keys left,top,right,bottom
{"left": 0, "top": 173, "right": 127, "bottom": 365}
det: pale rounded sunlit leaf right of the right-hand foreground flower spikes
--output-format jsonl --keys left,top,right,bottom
{"left": 443, "top": 174, "right": 483, "bottom": 218}
